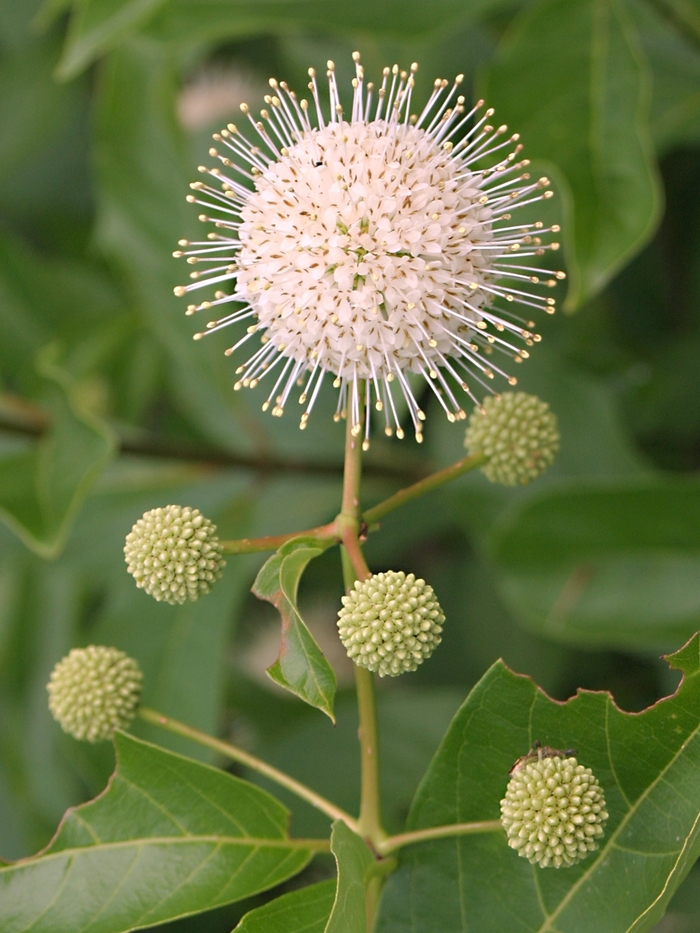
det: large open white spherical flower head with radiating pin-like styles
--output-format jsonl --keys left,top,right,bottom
{"left": 175, "top": 53, "right": 564, "bottom": 447}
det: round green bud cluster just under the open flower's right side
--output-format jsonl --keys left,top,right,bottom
{"left": 464, "top": 392, "right": 559, "bottom": 486}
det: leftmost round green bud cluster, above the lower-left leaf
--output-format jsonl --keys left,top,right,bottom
{"left": 46, "top": 645, "right": 143, "bottom": 742}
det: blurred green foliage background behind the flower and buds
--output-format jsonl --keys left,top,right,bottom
{"left": 0, "top": 0, "right": 700, "bottom": 933}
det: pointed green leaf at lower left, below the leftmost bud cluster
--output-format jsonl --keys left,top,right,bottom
{"left": 0, "top": 734, "right": 312, "bottom": 933}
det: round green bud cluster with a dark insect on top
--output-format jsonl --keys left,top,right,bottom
{"left": 501, "top": 756, "right": 608, "bottom": 868}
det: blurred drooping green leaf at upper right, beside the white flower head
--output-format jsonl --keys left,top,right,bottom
{"left": 483, "top": 0, "right": 660, "bottom": 308}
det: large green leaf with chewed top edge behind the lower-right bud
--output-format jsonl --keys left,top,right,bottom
{"left": 378, "top": 635, "right": 700, "bottom": 933}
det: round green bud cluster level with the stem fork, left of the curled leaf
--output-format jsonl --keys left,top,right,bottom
{"left": 124, "top": 505, "right": 226, "bottom": 603}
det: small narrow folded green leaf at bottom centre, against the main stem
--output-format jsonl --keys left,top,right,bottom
{"left": 325, "top": 820, "right": 377, "bottom": 933}
